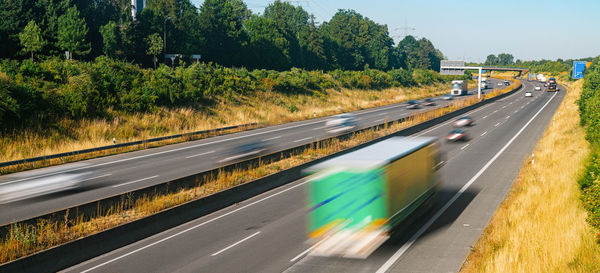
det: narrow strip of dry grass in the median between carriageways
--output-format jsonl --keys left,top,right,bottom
{"left": 0, "top": 84, "right": 520, "bottom": 263}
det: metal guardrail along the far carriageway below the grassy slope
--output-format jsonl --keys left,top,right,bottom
{"left": 0, "top": 123, "right": 258, "bottom": 168}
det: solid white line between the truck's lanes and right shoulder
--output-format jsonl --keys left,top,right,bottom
{"left": 376, "top": 91, "right": 556, "bottom": 273}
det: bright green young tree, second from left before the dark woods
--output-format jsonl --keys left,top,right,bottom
{"left": 58, "top": 7, "right": 90, "bottom": 59}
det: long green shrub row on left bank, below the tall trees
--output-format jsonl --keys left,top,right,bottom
{"left": 0, "top": 56, "right": 468, "bottom": 129}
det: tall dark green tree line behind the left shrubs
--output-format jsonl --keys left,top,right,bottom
{"left": 0, "top": 0, "right": 443, "bottom": 71}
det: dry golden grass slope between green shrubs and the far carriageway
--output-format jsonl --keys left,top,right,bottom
{"left": 0, "top": 84, "right": 448, "bottom": 165}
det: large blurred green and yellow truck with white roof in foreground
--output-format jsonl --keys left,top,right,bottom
{"left": 304, "top": 137, "right": 443, "bottom": 259}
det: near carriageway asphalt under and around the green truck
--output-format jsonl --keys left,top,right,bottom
{"left": 65, "top": 81, "right": 565, "bottom": 272}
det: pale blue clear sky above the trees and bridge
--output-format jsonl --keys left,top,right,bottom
{"left": 191, "top": 0, "right": 600, "bottom": 62}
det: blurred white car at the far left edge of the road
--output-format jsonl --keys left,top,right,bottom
{"left": 0, "top": 172, "right": 91, "bottom": 204}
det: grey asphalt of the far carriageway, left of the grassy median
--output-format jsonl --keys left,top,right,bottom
{"left": 0, "top": 79, "right": 504, "bottom": 225}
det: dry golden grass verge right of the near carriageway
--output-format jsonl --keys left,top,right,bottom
{"left": 461, "top": 81, "right": 600, "bottom": 273}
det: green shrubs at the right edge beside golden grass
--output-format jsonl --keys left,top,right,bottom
{"left": 578, "top": 56, "right": 600, "bottom": 233}
